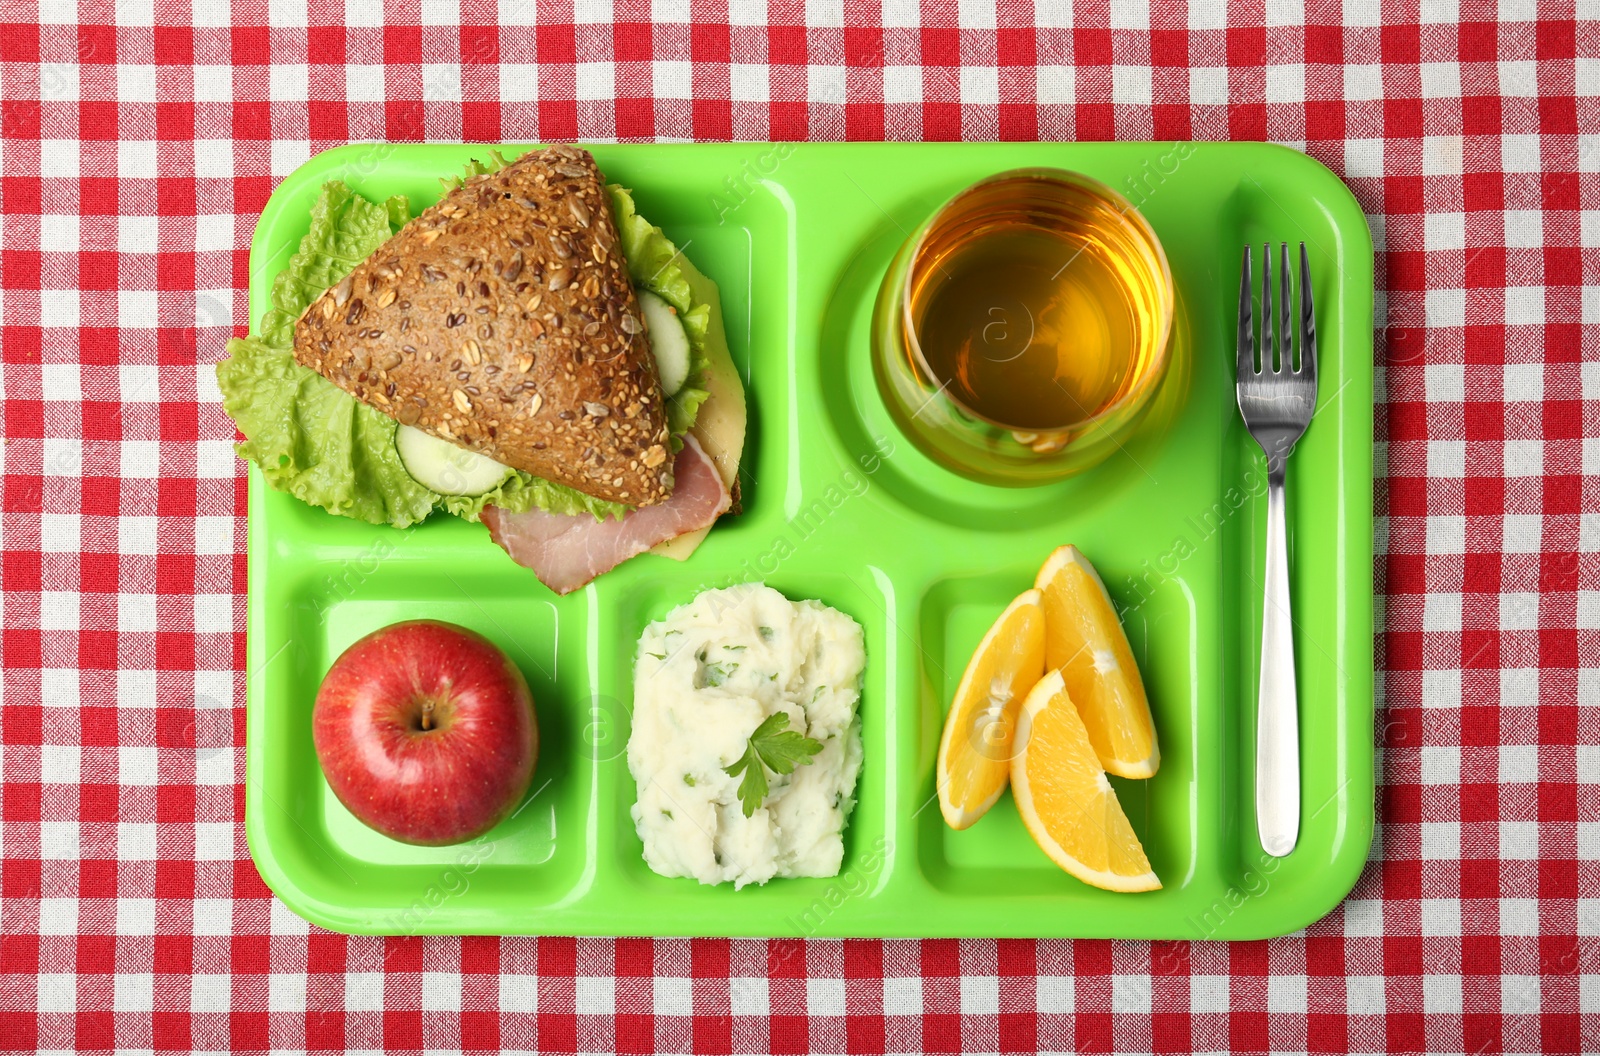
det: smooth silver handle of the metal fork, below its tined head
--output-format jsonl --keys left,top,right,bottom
{"left": 1256, "top": 458, "right": 1299, "bottom": 858}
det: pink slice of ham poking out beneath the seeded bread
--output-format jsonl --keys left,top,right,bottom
{"left": 483, "top": 437, "right": 733, "bottom": 594}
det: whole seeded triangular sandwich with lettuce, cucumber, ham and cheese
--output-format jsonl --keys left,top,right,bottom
{"left": 218, "top": 146, "right": 746, "bottom": 594}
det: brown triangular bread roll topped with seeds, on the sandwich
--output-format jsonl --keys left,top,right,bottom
{"left": 294, "top": 146, "right": 672, "bottom": 506}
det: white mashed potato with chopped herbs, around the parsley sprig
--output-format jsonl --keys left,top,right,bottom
{"left": 627, "top": 582, "right": 866, "bottom": 888}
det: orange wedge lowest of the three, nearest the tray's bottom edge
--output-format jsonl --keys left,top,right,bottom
{"left": 1011, "top": 670, "right": 1162, "bottom": 891}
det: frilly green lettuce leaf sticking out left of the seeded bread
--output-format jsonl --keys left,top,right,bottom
{"left": 216, "top": 181, "right": 627, "bottom": 528}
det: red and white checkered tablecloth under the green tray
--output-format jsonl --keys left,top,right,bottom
{"left": 0, "top": 0, "right": 1600, "bottom": 1053}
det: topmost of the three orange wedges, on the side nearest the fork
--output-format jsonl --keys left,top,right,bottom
{"left": 1034, "top": 546, "right": 1162, "bottom": 778}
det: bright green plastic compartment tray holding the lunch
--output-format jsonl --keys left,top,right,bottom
{"left": 245, "top": 142, "right": 1373, "bottom": 939}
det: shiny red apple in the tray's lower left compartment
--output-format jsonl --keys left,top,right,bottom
{"left": 312, "top": 619, "right": 539, "bottom": 846}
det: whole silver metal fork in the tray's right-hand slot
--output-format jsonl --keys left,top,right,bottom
{"left": 1237, "top": 242, "right": 1317, "bottom": 858}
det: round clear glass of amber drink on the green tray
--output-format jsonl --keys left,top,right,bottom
{"left": 872, "top": 168, "right": 1173, "bottom": 486}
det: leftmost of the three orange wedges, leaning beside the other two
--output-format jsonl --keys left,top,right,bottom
{"left": 934, "top": 590, "right": 1045, "bottom": 829}
